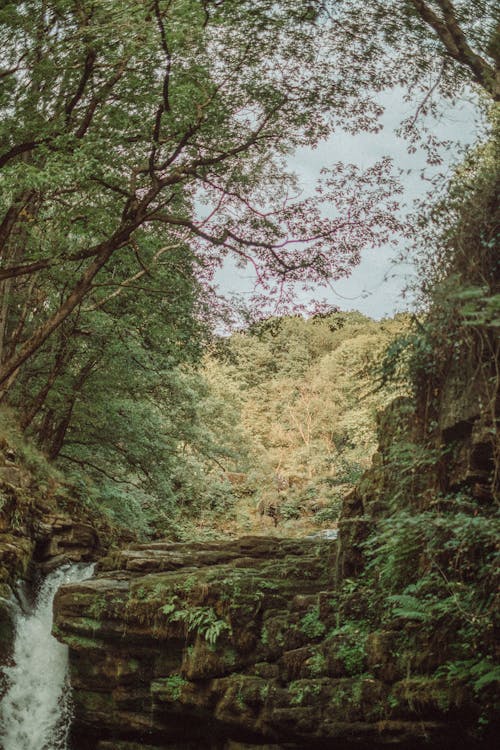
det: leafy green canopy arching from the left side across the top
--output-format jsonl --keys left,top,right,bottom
{"left": 0, "top": 0, "right": 499, "bottom": 528}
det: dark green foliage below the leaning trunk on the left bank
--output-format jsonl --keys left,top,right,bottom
{"left": 10, "top": 244, "right": 219, "bottom": 531}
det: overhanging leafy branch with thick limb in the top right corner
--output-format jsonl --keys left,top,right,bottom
{"left": 325, "top": 0, "right": 500, "bottom": 159}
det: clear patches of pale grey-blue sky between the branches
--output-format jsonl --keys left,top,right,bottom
{"left": 216, "top": 90, "right": 479, "bottom": 320}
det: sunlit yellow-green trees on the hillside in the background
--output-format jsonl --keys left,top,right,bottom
{"left": 205, "top": 311, "right": 408, "bottom": 533}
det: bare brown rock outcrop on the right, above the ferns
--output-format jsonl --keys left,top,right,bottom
{"left": 337, "top": 341, "right": 500, "bottom": 579}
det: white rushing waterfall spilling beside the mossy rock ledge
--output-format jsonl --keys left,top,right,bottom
{"left": 0, "top": 564, "right": 94, "bottom": 750}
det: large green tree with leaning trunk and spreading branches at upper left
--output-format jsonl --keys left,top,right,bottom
{"left": 0, "top": 0, "right": 402, "bottom": 387}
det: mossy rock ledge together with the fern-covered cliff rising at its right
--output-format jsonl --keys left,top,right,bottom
{"left": 51, "top": 332, "right": 498, "bottom": 750}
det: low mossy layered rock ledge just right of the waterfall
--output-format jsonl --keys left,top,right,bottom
{"left": 51, "top": 537, "right": 484, "bottom": 750}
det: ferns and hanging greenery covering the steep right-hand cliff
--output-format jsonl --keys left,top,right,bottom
{"left": 330, "top": 120, "right": 500, "bottom": 736}
